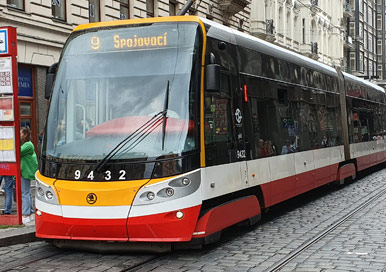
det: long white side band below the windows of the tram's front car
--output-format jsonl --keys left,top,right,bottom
{"left": 201, "top": 146, "right": 344, "bottom": 200}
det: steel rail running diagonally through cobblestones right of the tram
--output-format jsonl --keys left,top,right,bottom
{"left": 265, "top": 181, "right": 386, "bottom": 272}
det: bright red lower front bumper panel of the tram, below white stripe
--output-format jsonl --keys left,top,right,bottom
{"left": 36, "top": 205, "right": 201, "bottom": 242}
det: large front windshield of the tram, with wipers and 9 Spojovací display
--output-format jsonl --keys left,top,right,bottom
{"left": 42, "top": 22, "right": 201, "bottom": 161}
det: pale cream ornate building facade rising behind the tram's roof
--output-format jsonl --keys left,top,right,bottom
{"left": 251, "top": 0, "right": 346, "bottom": 66}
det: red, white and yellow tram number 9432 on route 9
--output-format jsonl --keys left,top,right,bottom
{"left": 36, "top": 13, "right": 386, "bottom": 251}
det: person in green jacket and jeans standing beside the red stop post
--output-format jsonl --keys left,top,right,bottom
{"left": 20, "top": 127, "right": 38, "bottom": 224}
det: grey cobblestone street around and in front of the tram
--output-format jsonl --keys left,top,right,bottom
{"left": 0, "top": 167, "right": 386, "bottom": 272}
